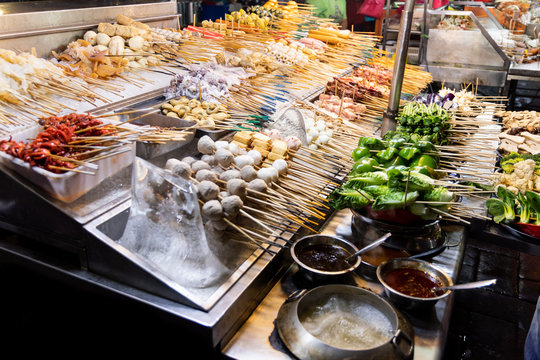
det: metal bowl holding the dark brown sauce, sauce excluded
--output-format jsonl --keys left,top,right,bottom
{"left": 291, "top": 234, "right": 362, "bottom": 280}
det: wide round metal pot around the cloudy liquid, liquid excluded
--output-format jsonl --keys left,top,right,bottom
{"left": 276, "top": 284, "right": 414, "bottom": 360}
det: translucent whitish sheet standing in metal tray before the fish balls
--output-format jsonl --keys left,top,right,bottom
{"left": 118, "top": 158, "right": 230, "bottom": 288}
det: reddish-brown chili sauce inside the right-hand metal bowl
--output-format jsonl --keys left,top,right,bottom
{"left": 384, "top": 268, "right": 445, "bottom": 298}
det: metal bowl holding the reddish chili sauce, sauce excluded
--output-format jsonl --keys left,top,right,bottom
{"left": 377, "top": 259, "right": 453, "bottom": 311}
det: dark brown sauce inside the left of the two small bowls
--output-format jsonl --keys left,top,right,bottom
{"left": 296, "top": 244, "right": 356, "bottom": 272}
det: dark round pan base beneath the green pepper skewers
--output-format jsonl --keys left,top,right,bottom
{"left": 351, "top": 210, "right": 446, "bottom": 255}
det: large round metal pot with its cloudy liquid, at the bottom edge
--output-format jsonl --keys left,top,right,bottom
{"left": 276, "top": 284, "right": 414, "bottom": 360}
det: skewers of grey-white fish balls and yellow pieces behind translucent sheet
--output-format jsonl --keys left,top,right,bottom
{"left": 161, "top": 131, "right": 348, "bottom": 253}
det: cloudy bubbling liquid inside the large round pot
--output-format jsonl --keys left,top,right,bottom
{"left": 300, "top": 296, "right": 395, "bottom": 350}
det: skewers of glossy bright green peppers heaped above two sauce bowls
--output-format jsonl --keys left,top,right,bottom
{"left": 330, "top": 132, "right": 494, "bottom": 224}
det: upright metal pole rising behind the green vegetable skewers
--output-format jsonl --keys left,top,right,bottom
{"left": 381, "top": 0, "right": 415, "bottom": 136}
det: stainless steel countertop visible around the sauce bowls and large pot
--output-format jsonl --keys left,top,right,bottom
{"left": 223, "top": 210, "right": 465, "bottom": 360}
